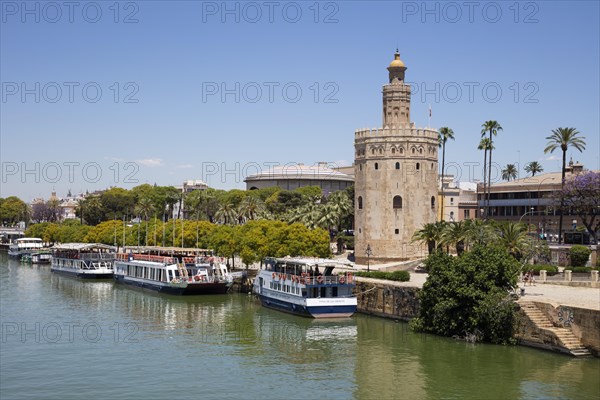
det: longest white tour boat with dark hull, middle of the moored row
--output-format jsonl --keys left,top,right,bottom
{"left": 114, "top": 253, "right": 233, "bottom": 295}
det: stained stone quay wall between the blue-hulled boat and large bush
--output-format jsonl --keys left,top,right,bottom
{"left": 355, "top": 278, "right": 421, "bottom": 321}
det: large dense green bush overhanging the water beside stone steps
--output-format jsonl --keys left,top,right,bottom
{"left": 411, "top": 245, "right": 519, "bottom": 343}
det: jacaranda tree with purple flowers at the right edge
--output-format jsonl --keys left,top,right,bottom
{"left": 557, "top": 171, "right": 600, "bottom": 243}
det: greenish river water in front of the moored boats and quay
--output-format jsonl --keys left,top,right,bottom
{"left": 0, "top": 254, "right": 600, "bottom": 400}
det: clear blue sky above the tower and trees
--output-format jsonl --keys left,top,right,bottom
{"left": 0, "top": 0, "right": 600, "bottom": 200}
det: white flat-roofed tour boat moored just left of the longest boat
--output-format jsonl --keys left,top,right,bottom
{"left": 50, "top": 243, "right": 117, "bottom": 279}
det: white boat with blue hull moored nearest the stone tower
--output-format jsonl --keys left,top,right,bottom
{"left": 254, "top": 257, "right": 357, "bottom": 318}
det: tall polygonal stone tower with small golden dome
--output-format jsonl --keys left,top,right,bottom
{"left": 354, "top": 50, "right": 438, "bottom": 264}
